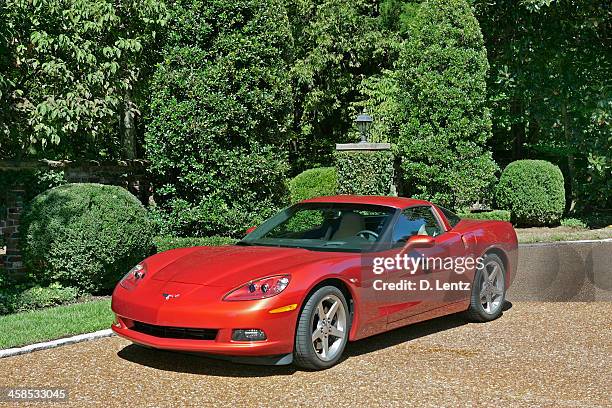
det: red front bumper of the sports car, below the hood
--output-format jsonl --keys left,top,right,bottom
{"left": 112, "top": 287, "right": 300, "bottom": 357}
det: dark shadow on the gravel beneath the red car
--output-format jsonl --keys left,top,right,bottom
{"left": 117, "top": 301, "right": 512, "bottom": 377}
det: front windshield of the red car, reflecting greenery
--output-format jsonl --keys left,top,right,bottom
{"left": 238, "top": 203, "right": 396, "bottom": 252}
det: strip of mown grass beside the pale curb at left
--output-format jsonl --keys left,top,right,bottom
{"left": 0, "top": 299, "right": 113, "bottom": 349}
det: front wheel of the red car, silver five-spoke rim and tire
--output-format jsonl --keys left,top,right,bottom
{"left": 294, "top": 286, "right": 350, "bottom": 370}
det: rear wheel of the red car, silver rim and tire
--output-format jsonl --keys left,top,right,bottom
{"left": 467, "top": 254, "right": 506, "bottom": 322}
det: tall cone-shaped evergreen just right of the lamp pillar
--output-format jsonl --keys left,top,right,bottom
{"left": 362, "top": 0, "right": 497, "bottom": 208}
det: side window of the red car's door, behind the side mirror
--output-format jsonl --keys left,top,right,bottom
{"left": 392, "top": 206, "right": 444, "bottom": 243}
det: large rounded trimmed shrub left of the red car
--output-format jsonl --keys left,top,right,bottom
{"left": 21, "top": 183, "right": 153, "bottom": 293}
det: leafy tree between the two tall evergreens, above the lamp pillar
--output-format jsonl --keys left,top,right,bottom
{"left": 287, "top": 0, "right": 396, "bottom": 173}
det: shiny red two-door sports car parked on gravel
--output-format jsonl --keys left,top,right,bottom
{"left": 112, "top": 196, "right": 517, "bottom": 369}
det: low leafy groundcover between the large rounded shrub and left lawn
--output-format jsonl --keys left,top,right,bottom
{"left": 0, "top": 283, "right": 79, "bottom": 314}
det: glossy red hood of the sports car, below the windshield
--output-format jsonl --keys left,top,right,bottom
{"left": 153, "top": 245, "right": 347, "bottom": 289}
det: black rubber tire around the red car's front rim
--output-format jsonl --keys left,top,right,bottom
{"left": 293, "top": 286, "right": 351, "bottom": 370}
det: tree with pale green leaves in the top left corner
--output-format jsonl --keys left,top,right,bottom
{"left": 0, "top": 0, "right": 166, "bottom": 159}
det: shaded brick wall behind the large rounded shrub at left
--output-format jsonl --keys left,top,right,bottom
{"left": 0, "top": 160, "right": 151, "bottom": 278}
